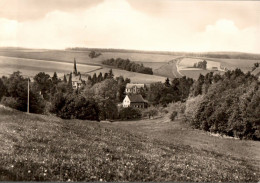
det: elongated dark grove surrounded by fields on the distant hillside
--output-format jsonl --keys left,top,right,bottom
{"left": 102, "top": 58, "right": 153, "bottom": 75}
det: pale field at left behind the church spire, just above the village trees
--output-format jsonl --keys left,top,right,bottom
{"left": 0, "top": 56, "right": 101, "bottom": 77}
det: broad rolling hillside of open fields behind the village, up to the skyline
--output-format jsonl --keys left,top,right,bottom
{"left": 0, "top": 48, "right": 260, "bottom": 83}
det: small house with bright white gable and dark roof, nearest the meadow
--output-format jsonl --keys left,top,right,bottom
{"left": 123, "top": 94, "right": 148, "bottom": 108}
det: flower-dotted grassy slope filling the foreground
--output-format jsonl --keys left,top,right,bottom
{"left": 0, "top": 107, "right": 259, "bottom": 182}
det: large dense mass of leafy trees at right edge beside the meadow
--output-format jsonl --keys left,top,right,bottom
{"left": 186, "top": 69, "right": 260, "bottom": 140}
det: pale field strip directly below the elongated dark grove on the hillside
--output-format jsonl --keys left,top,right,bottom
{"left": 87, "top": 68, "right": 166, "bottom": 84}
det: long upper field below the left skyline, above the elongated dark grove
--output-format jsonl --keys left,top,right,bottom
{"left": 0, "top": 48, "right": 180, "bottom": 64}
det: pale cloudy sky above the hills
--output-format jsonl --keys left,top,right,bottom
{"left": 0, "top": 0, "right": 260, "bottom": 53}
